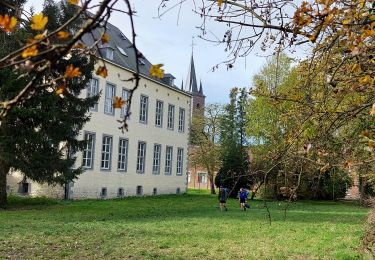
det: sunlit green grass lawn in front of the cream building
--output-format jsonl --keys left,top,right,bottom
{"left": 0, "top": 191, "right": 368, "bottom": 259}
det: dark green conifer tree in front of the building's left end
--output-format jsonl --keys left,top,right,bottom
{"left": 0, "top": 0, "right": 98, "bottom": 208}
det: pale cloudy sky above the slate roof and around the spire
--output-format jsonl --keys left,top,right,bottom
{"left": 29, "top": 0, "right": 306, "bottom": 103}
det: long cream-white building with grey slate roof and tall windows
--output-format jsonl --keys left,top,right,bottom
{"left": 7, "top": 21, "right": 203, "bottom": 199}
